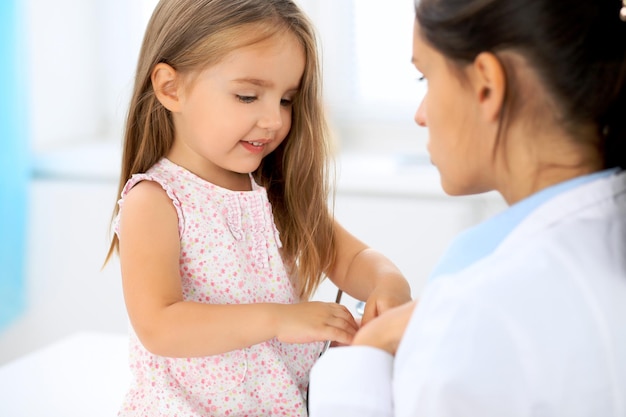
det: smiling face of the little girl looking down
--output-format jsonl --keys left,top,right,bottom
{"left": 168, "top": 33, "right": 305, "bottom": 189}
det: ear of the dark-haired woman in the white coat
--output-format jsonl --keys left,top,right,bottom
{"left": 473, "top": 52, "right": 506, "bottom": 121}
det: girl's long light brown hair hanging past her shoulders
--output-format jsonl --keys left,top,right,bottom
{"left": 107, "top": 0, "right": 335, "bottom": 299}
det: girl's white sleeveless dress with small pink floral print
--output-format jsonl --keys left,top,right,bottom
{"left": 115, "top": 158, "right": 322, "bottom": 417}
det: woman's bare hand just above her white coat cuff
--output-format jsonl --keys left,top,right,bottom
{"left": 352, "top": 301, "right": 417, "bottom": 356}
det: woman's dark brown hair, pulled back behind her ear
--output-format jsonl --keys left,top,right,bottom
{"left": 415, "top": 0, "right": 626, "bottom": 169}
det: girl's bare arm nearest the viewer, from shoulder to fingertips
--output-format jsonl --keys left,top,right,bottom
{"left": 119, "top": 181, "right": 357, "bottom": 357}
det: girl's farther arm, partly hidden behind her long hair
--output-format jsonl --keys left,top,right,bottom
{"left": 328, "top": 222, "right": 411, "bottom": 324}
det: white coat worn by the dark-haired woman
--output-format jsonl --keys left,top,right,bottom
{"left": 309, "top": 173, "right": 626, "bottom": 417}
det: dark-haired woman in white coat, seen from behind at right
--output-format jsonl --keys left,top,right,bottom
{"left": 309, "top": 0, "right": 626, "bottom": 417}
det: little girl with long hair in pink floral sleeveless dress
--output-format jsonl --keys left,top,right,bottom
{"left": 109, "top": 0, "right": 410, "bottom": 416}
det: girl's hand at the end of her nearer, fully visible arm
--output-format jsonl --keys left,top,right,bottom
{"left": 276, "top": 301, "right": 359, "bottom": 344}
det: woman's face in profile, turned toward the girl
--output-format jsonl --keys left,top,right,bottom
{"left": 413, "top": 23, "right": 493, "bottom": 195}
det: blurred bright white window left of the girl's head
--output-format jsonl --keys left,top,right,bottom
{"left": 24, "top": 0, "right": 148, "bottom": 152}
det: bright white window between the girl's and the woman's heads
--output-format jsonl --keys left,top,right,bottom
{"left": 300, "top": 0, "right": 426, "bottom": 154}
